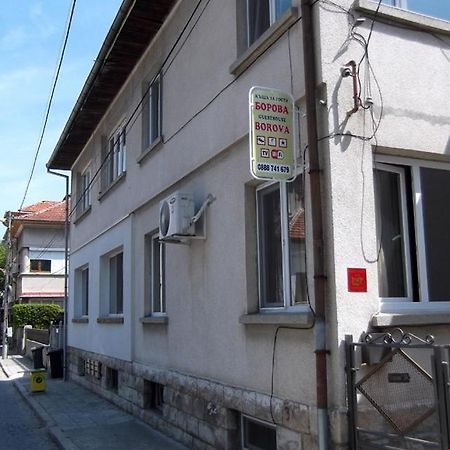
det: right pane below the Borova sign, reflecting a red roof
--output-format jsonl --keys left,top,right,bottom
{"left": 287, "top": 175, "right": 306, "bottom": 303}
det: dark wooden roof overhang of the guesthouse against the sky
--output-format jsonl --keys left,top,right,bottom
{"left": 47, "top": 0, "right": 176, "bottom": 170}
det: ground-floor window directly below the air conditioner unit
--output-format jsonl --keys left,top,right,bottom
{"left": 146, "top": 232, "right": 166, "bottom": 315}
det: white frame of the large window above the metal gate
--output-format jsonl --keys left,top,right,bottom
{"left": 375, "top": 155, "right": 450, "bottom": 313}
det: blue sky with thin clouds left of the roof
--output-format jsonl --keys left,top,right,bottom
{"left": 0, "top": 0, "right": 121, "bottom": 217}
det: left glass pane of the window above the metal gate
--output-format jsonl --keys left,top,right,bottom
{"left": 375, "top": 170, "right": 407, "bottom": 297}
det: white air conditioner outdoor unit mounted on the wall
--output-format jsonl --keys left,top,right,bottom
{"left": 159, "top": 191, "right": 195, "bottom": 240}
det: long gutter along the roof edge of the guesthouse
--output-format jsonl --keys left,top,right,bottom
{"left": 47, "top": 0, "right": 136, "bottom": 170}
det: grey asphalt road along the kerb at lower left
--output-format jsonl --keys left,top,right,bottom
{"left": 0, "top": 370, "right": 58, "bottom": 450}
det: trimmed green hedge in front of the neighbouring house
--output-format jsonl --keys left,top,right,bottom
{"left": 11, "top": 304, "right": 63, "bottom": 329}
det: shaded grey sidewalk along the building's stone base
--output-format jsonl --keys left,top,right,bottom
{"left": 0, "top": 356, "right": 186, "bottom": 450}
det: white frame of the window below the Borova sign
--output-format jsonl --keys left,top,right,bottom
{"left": 256, "top": 175, "right": 307, "bottom": 312}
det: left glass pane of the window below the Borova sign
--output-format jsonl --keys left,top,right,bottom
{"left": 258, "top": 184, "right": 284, "bottom": 307}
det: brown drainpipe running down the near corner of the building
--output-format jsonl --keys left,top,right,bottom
{"left": 301, "top": 0, "right": 329, "bottom": 450}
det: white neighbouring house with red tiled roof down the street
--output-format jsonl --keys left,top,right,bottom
{"left": 7, "top": 200, "right": 66, "bottom": 306}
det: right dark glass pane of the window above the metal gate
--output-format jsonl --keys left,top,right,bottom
{"left": 420, "top": 168, "right": 450, "bottom": 301}
